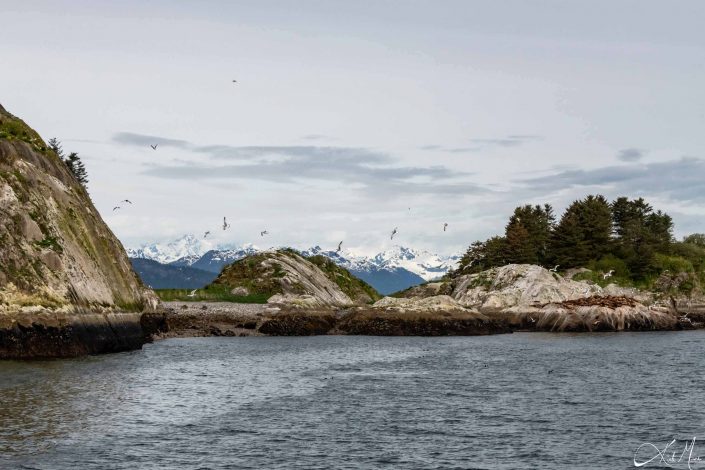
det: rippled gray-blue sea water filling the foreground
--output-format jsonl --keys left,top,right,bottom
{"left": 0, "top": 331, "right": 705, "bottom": 469}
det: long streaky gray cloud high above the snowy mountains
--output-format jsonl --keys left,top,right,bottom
{"left": 115, "top": 133, "right": 488, "bottom": 195}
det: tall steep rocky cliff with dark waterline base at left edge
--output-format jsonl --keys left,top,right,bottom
{"left": 0, "top": 106, "right": 157, "bottom": 357}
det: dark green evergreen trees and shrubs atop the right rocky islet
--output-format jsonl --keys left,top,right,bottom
{"left": 459, "top": 195, "right": 705, "bottom": 281}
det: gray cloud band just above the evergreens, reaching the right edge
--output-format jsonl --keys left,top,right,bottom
{"left": 521, "top": 157, "right": 705, "bottom": 203}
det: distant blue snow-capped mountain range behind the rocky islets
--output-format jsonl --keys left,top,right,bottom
{"left": 127, "top": 235, "right": 460, "bottom": 295}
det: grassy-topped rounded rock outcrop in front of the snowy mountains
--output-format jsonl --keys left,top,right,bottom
{"left": 213, "top": 250, "right": 378, "bottom": 309}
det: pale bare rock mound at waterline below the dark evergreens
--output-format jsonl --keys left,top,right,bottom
{"left": 390, "top": 264, "right": 690, "bottom": 331}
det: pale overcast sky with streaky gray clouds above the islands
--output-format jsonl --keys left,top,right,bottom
{"left": 0, "top": 0, "right": 705, "bottom": 254}
